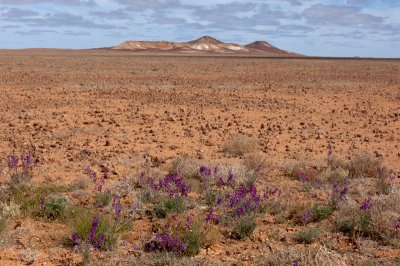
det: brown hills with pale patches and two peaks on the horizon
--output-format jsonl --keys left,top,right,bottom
{"left": 110, "top": 36, "right": 301, "bottom": 56}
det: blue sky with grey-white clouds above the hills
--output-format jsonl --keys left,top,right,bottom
{"left": 0, "top": 0, "right": 400, "bottom": 57}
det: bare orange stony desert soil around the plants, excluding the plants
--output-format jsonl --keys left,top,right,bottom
{"left": 0, "top": 50, "right": 400, "bottom": 265}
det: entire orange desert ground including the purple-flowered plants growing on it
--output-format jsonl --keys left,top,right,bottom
{"left": 0, "top": 55, "right": 400, "bottom": 266}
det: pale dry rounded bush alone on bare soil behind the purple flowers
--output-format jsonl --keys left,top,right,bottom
{"left": 222, "top": 134, "right": 258, "bottom": 156}
